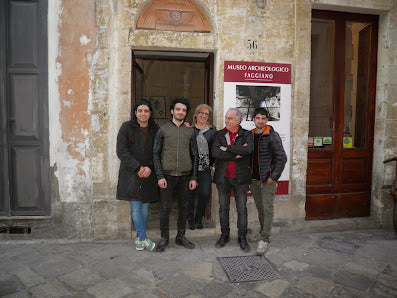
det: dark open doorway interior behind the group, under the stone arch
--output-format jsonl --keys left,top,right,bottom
{"left": 131, "top": 50, "right": 214, "bottom": 230}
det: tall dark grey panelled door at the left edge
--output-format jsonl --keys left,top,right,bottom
{"left": 0, "top": 0, "right": 50, "bottom": 216}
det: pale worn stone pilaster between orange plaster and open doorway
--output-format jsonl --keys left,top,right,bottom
{"left": 90, "top": 1, "right": 131, "bottom": 239}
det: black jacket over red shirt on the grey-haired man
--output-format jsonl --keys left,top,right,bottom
{"left": 211, "top": 127, "right": 253, "bottom": 184}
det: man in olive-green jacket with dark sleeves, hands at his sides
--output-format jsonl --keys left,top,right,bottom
{"left": 153, "top": 97, "right": 198, "bottom": 252}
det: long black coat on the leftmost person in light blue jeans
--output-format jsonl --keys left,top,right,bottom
{"left": 116, "top": 119, "right": 159, "bottom": 203}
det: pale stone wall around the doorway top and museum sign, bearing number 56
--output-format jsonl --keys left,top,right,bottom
{"left": 119, "top": 0, "right": 310, "bottom": 237}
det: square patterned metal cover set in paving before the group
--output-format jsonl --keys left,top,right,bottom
{"left": 217, "top": 256, "right": 281, "bottom": 282}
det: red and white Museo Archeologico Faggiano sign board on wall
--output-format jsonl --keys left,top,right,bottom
{"left": 223, "top": 61, "right": 291, "bottom": 195}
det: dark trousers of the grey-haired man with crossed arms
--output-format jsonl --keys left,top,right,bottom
{"left": 216, "top": 178, "right": 249, "bottom": 236}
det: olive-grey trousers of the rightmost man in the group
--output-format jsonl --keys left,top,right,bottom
{"left": 251, "top": 180, "right": 277, "bottom": 242}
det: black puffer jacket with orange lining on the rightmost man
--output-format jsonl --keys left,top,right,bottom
{"left": 251, "top": 125, "right": 287, "bottom": 183}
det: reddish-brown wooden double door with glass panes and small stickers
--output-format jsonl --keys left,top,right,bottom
{"left": 306, "top": 10, "right": 378, "bottom": 220}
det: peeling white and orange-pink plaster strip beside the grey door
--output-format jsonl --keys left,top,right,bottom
{"left": 48, "top": 0, "right": 97, "bottom": 238}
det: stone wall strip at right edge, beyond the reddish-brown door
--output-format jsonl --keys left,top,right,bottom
{"left": 371, "top": 0, "right": 397, "bottom": 227}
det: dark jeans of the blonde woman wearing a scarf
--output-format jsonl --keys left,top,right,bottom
{"left": 187, "top": 171, "right": 212, "bottom": 223}
